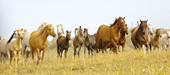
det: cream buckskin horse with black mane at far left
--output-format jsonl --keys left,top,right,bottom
{"left": 7, "top": 30, "right": 23, "bottom": 65}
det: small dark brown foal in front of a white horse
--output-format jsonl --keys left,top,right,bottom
{"left": 56, "top": 31, "right": 71, "bottom": 58}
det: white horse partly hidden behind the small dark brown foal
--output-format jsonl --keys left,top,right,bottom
{"left": 52, "top": 24, "right": 66, "bottom": 47}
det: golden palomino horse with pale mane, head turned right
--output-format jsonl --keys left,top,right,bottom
{"left": 29, "top": 24, "right": 56, "bottom": 65}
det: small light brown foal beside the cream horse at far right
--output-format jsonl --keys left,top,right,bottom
{"left": 149, "top": 29, "right": 162, "bottom": 50}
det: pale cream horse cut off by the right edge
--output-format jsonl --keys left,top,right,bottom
{"left": 160, "top": 30, "right": 170, "bottom": 49}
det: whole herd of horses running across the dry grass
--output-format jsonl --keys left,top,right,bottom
{"left": 0, "top": 17, "right": 170, "bottom": 65}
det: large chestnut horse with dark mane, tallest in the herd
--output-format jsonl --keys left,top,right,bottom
{"left": 95, "top": 17, "right": 126, "bottom": 53}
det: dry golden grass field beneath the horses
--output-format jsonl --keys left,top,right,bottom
{"left": 0, "top": 44, "right": 170, "bottom": 75}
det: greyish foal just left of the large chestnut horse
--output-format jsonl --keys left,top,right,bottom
{"left": 83, "top": 28, "right": 96, "bottom": 55}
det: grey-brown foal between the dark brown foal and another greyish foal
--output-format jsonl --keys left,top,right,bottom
{"left": 73, "top": 28, "right": 84, "bottom": 57}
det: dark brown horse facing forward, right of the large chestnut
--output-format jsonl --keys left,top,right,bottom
{"left": 131, "top": 20, "right": 148, "bottom": 50}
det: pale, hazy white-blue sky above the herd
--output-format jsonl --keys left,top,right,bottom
{"left": 0, "top": 0, "right": 170, "bottom": 41}
